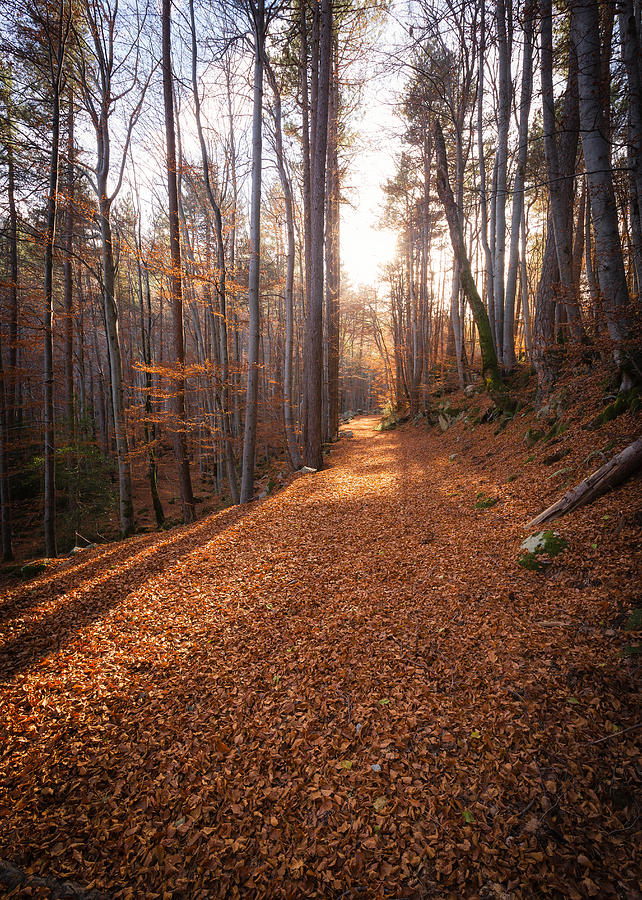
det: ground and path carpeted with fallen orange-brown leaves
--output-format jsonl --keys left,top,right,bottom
{"left": 0, "top": 392, "right": 642, "bottom": 900}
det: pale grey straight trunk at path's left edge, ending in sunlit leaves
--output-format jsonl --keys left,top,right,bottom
{"left": 241, "top": 0, "right": 265, "bottom": 503}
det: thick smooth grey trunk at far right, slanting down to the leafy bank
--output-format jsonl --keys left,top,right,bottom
{"left": 570, "top": 0, "right": 642, "bottom": 387}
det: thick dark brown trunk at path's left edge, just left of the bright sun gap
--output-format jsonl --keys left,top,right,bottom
{"left": 303, "top": 0, "right": 332, "bottom": 469}
